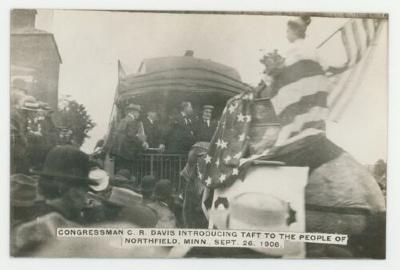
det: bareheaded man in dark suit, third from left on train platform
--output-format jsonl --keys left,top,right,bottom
{"left": 167, "top": 101, "right": 195, "bottom": 153}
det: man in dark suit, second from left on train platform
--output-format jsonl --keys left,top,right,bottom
{"left": 143, "top": 109, "right": 165, "bottom": 152}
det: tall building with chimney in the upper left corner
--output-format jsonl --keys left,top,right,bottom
{"left": 10, "top": 9, "right": 62, "bottom": 109}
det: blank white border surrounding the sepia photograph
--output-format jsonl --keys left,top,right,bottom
{"left": 0, "top": 0, "right": 400, "bottom": 270}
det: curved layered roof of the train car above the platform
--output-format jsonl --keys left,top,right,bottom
{"left": 118, "top": 56, "right": 251, "bottom": 103}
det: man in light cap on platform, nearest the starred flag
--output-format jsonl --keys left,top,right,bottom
{"left": 195, "top": 105, "right": 217, "bottom": 142}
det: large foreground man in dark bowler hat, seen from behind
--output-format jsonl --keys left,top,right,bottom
{"left": 11, "top": 146, "right": 97, "bottom": 256}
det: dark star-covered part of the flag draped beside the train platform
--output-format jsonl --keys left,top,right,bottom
{"left": 198, "top": 91, "right": 254, "bottom": 188}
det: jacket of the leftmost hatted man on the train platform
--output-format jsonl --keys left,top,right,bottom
{"left": 111, "top": 115, "right": 143, "bottom": 160}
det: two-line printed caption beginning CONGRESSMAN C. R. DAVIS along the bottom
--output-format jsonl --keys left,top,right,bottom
{"left": 57, "top": 228, "right": 348, "bottom": 248}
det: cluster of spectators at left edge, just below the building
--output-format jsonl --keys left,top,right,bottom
{"left": 10, "top": 79, "right": 79, "bottom": 173}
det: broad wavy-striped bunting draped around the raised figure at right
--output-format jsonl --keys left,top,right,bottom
{"left": 271, "top": 55, "right": 330, "bottom": 146}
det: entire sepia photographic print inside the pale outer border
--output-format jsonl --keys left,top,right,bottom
{"left": 9, "top": 8, "right": 389, "bottom": 260}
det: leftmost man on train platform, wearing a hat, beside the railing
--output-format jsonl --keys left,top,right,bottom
{"left": 111, "top": 103, "right": 148, "bottom": 172}
